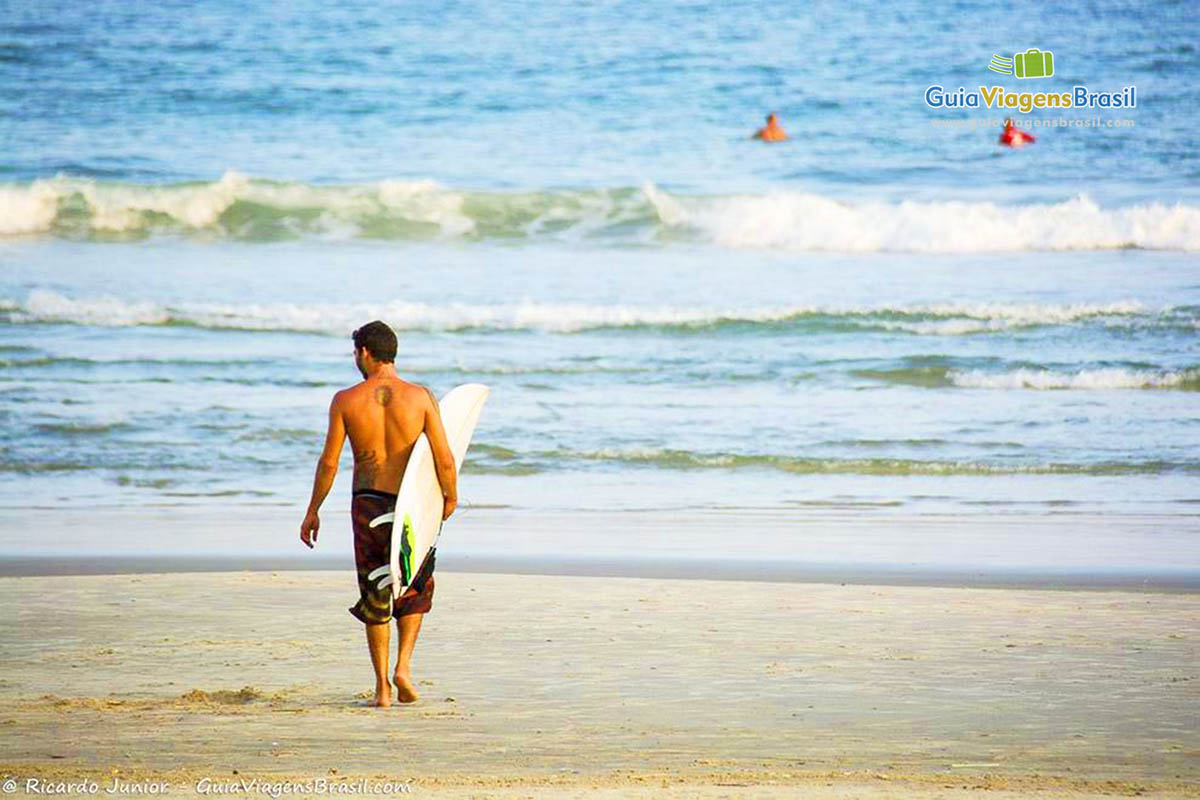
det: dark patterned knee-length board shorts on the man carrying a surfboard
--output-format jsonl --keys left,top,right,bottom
{"left": 349, "top": 489, "right": 434, "bottom": 625}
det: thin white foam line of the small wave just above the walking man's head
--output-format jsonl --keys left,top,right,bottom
{"left": 7, "top": 289, "right": 1171, "bottom": 336}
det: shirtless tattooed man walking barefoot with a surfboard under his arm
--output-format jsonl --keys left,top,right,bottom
{"left": 300, "top": 320, "right": 458, "bottom": 708}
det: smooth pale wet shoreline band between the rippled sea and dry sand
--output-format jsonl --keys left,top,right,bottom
{"left": 0, "top": 500, "right": 1200, "bottom": 593}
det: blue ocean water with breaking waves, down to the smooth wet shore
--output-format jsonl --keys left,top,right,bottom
{"left": 0, "top": 0, "right": 1200, "bottom": 556}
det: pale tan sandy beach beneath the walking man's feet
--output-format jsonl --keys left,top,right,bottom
{"left": 0, "top": 571, "right": 1200, "bottom": 798}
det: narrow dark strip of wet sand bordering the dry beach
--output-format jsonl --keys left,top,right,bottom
{"left": 0, "top": 553, "right": 1200, "bottom": 594}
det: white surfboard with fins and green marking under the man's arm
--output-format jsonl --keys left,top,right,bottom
{"left": 367, "top": 384, "right": 492, "bottom": 599}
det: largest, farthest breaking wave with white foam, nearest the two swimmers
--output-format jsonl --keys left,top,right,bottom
{"left": 0, "top": 172, "right": 1200, "bottom": 253}
